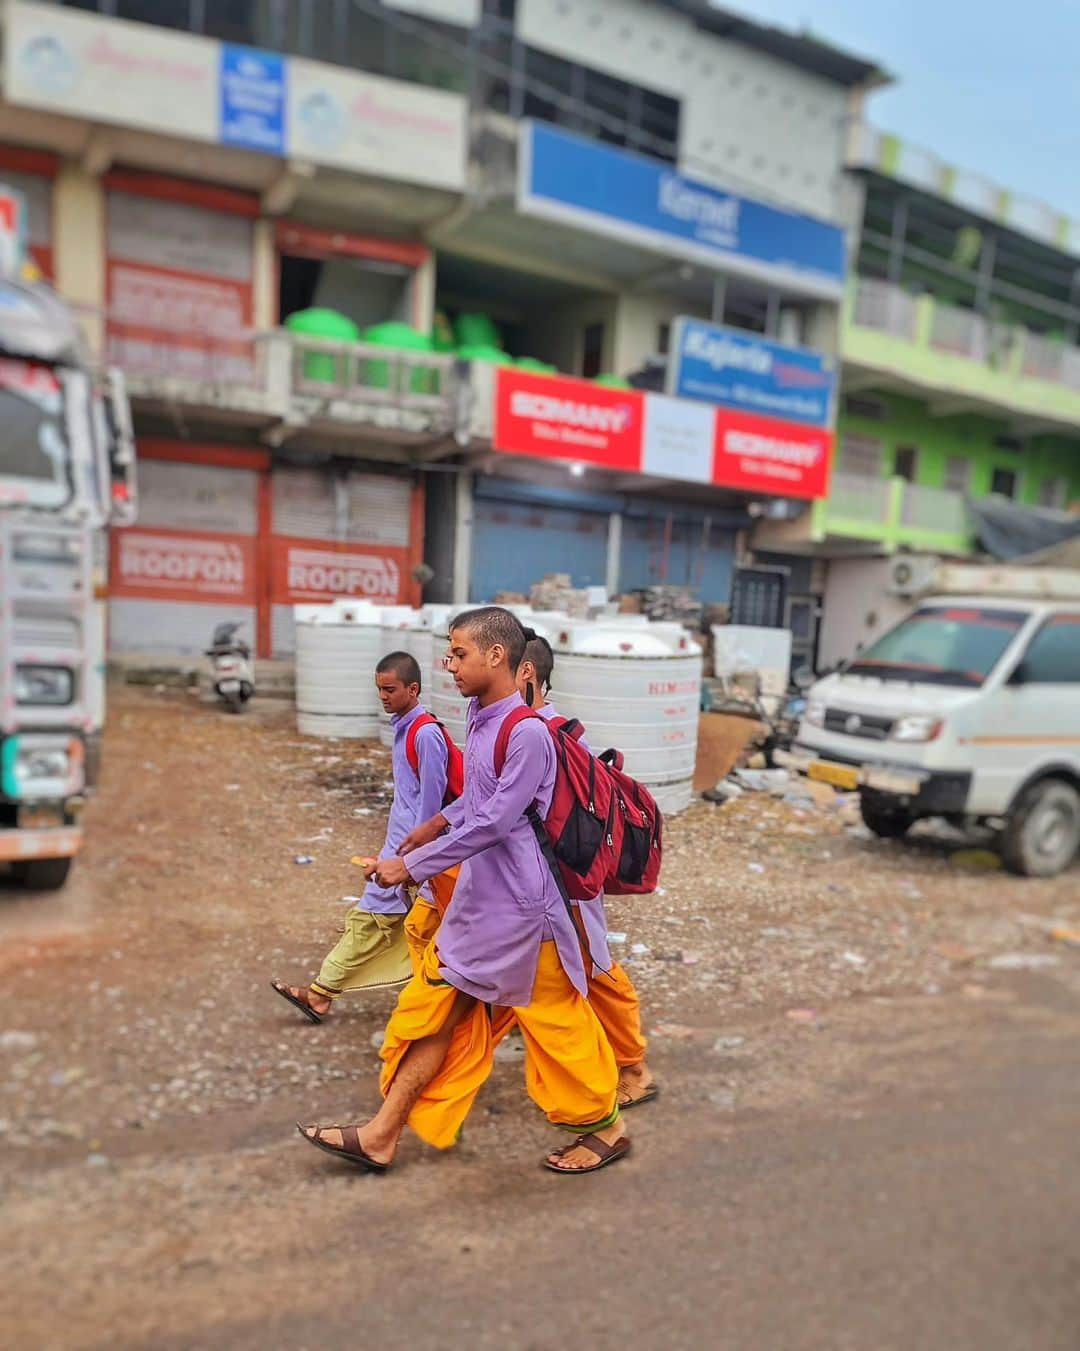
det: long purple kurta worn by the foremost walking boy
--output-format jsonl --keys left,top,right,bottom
{"left": 404, "top": 693, "right": 588, "bottom": 1008}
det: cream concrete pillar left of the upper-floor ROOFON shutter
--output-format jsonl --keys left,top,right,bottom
{"left": 53, "top": 162, "right": 105, "bottom": 354}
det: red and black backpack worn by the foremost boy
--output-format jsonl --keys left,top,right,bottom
{"left": 495, "top": 705, "right": 664, "bottom": 901}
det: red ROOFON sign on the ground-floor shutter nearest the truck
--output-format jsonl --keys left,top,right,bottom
{"left": 109, "top": 528, "right": 255, "bottom": 605}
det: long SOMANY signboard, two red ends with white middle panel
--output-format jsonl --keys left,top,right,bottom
{"left": 492, "top": 367, "right": 833, "bottom": 499}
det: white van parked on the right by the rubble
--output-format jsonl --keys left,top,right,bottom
{"left": 785, "top": 566, "right": 1080, "bottom": 877}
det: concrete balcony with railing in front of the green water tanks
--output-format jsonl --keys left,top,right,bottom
{"left": 91, "top": 317, "right": 461, "bottom": 444}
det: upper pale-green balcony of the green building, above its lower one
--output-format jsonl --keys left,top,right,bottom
{"left": 842, "top": 277, "right": 1080, "bottom": 431}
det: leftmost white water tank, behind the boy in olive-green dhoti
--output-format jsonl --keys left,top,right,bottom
{"left": 293, "top": 600, "right": 383, "bottom": 738}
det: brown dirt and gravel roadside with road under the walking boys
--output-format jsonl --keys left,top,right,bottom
{"left": 0, "top": 690, "right": 1080, "bottom": 1351}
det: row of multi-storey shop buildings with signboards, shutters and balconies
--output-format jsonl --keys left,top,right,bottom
{"left": 0, "top": 0, "right": 1080, "bottom": 657}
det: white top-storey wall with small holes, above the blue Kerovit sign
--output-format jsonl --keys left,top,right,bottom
{"left": 518, "top": 0, "right": 849, "bottom": 223}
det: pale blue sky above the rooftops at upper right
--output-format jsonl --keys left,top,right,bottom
{"left": 746, "top": 0, "right": 1080, "bottom": 216}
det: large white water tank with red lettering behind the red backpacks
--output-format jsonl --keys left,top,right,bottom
{"left": 551, "top": 616, "right": 702, "bottom": 815}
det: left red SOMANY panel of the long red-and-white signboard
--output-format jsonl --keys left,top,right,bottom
{"left": 492, "top": 369, "right": 645, "bottom": 473}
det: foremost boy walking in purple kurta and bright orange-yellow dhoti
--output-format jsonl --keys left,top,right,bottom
{"left": 299, "top": 607, "right": 630, "bottom": 1173}
